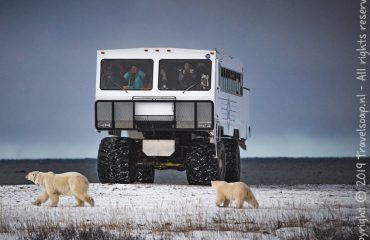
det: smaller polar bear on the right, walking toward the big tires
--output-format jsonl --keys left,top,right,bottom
{"left": 211, "top": 181, "right": 259, "bottom": 208}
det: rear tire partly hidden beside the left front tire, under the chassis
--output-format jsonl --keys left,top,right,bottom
{"left": 136, "top": 140, "right": 155, "bottom": 183}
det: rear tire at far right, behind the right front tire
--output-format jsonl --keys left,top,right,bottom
{"left": 222, "top": 139, "right": 240, "bottom": 182}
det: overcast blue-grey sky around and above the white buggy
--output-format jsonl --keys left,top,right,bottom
{"left": 0, "top": 0, "right": 359, "bottom": 159}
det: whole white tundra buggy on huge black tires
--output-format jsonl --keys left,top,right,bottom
{"left": 95, "top": 48, "right": 250, "bottom": 185}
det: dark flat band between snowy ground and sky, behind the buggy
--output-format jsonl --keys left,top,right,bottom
{"left": 0, "top": 158, "right": 370, "bottom": 185}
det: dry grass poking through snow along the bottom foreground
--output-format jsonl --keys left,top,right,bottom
{"left": 0, "top": 200, "right": 370, "bottom": 240}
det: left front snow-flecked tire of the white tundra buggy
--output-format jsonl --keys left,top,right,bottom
{"left": 97, "top": 137, "right": 136, "bottom": 183}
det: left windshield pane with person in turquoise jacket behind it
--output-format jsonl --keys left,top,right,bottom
{"left": 100, "top": 59, "right": 153, "bottom": 90}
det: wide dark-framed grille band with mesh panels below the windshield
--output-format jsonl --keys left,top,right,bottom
{"left": 95, "top": 100, "right": 214, "bottom": 130}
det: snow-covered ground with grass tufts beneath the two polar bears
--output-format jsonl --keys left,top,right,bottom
{"left": 0, "top": 184, "right": 369, "bottom": 239}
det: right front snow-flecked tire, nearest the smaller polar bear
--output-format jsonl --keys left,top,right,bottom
{"left": 185, "top": 141, "right": 226, "bottom": 185}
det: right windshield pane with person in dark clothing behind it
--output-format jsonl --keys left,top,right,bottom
{"left": 158, "top": 59, "right": 212, "bottom": 91}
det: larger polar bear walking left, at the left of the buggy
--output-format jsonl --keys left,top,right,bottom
{"left": 26, "top": 171, "right": 94, "bottom": 207}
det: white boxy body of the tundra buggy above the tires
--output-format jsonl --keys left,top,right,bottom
{"left": 95, "top": 48, "right": 250, "bottom": 143}
